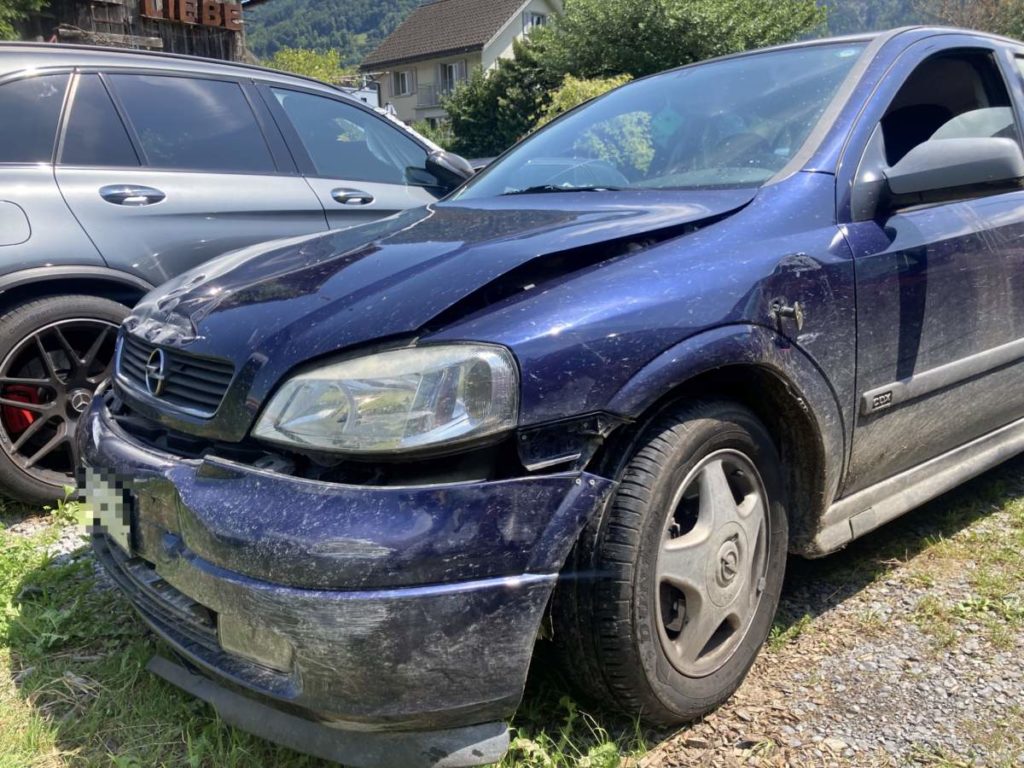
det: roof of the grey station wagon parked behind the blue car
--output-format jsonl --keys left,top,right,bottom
{"left": 0, "top": 42, "right": 358, "bottom": 101}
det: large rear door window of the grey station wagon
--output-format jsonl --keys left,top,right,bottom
{"left": 109, "top": 75, "right": 276, "bottom": 173}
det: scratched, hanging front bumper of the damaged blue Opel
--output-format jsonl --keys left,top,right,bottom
{"left": 80, "top": 397, "right": 612, "bottom": 766}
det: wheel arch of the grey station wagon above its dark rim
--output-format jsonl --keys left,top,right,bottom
{"left": 0, "top": 266, "right": 154, "bottom": 314}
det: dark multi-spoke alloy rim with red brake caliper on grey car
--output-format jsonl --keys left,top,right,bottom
{"left": 0, "top": 317, "right": 117, "bottom": 485}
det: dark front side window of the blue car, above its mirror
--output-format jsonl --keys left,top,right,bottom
{"left": 882, "top": 51, "right": 1019, "bottom": 166}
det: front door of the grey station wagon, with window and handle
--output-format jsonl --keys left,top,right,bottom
{"left": 261, "top": 85, "right": 442, "bottom": 228}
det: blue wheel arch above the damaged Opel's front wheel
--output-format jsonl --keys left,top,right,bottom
{"left": 592, "top": 326, "right": 847, "bottom": 554}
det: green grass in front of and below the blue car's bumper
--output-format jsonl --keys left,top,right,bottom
{"left": 0, "top": 502, "right": 646, "bottom": 768}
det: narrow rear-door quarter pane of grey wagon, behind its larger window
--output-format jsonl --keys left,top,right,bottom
{"left": 60, "top": 75, "right": 138, "bottom": 168}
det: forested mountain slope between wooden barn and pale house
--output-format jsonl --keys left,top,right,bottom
{"left": 246, "top": 0, "right": 420, "bottom": 65}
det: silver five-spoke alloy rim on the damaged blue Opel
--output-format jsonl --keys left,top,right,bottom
{"left": 655, "top": 450, "right": 770, "bottom": 677}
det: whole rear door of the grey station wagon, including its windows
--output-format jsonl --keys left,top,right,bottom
{"left": 56, "top": 72, "right": 327, "bottom": 284}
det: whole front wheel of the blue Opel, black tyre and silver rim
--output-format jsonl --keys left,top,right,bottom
{"left": 553, "top": 401, "right": 788, "bottom": 726}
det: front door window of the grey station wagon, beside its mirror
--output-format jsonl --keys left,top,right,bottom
{"left": 272, "top": 88, "right": 437, "bottom": 186}
